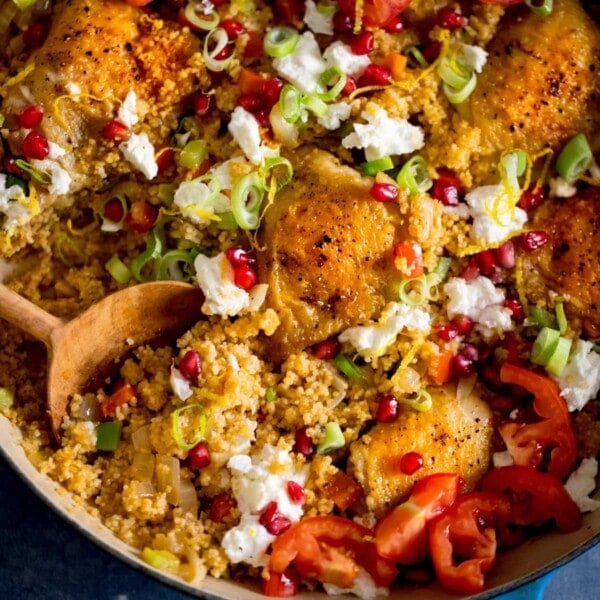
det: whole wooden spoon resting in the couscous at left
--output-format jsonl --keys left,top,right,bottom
{"left": 0, "top": 281, "right": 204, "bottom": 440}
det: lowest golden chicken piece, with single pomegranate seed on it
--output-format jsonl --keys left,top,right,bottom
{"left": 349, "top": 387, "right": 492, "bottom": 517}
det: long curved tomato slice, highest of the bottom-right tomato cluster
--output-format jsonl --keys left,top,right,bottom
{"left": 498, "top": 363, "right": 577, "bottom": 479}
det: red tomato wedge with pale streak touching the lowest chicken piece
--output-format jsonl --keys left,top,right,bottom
{"left": 375, "top": 473, "right": 461, "bottom": 565}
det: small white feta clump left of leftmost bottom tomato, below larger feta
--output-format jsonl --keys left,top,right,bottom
{"left": 221, "top": 514, "right": 275, "bottom": 567}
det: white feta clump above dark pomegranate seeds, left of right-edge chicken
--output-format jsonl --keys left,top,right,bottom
{"left": 444, "top": 277, "right": 513, "bottom": 339}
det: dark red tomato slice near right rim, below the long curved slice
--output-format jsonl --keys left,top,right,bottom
{"left": 482, "top": 465, "right": 581, "bottom": 531}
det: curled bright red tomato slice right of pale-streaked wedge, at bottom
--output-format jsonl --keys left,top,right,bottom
{"left": 429, "top": 492, "right": 510, "bottom": 594}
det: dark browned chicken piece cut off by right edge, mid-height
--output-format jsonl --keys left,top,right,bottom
{"left": 524, "top": 188, "right": 600, "bottom": 337}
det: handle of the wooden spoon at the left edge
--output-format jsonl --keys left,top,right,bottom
{"left": 0, "top": 284, "right": 65, "bottom": 346}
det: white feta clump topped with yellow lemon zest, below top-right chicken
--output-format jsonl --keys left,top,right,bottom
{"left": 465, "top": 184, "right": 527, "bottom": 244}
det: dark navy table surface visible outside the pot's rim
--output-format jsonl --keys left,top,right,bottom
{"left": 0, "top": 456, "right": 600, "bottom": 600}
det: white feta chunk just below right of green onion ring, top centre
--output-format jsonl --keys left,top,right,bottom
{"left": 274, "top": 31, "right": 327, "bottom": 93}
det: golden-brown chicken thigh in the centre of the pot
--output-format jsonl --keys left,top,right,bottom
{"left": 258, "top": 150, "right": 400, "bottom": 357}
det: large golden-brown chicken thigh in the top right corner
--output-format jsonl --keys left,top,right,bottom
{"left": 470, "top": 0, "right": 600, "bottom": 153}
